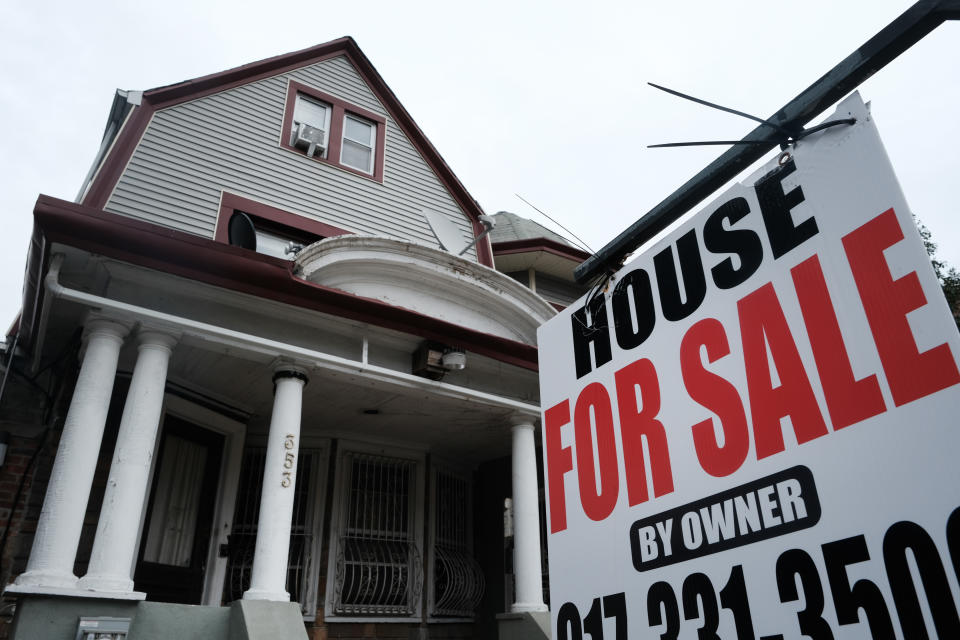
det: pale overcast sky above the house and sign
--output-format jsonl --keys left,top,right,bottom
{"left": 0, "top": 0, "right": 960, "bottom": 328}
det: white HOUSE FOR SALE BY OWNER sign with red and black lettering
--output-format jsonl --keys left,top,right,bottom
{"left": 539, "top": 95, "right": 960, "bottom": 640}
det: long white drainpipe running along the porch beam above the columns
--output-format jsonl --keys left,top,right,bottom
{"left": 44, "top": 253, "right": 540, "bottom": 419}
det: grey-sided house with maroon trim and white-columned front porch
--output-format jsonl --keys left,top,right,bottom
{"left": 0, "top": 38, "right": 587, "bottom": 639}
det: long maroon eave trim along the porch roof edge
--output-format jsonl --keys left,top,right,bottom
{"left": 34, "top": 196, "right": 537, "bottom": 371}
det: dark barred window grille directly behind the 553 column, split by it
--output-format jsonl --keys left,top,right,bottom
{"left": 224, "top": 448, "right": 327, "bottom": 620}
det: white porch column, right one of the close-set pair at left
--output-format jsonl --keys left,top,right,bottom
{"left": 79, "top": 330, "right": 177, "bottom": 597}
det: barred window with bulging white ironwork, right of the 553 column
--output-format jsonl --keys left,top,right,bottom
{"left": 332, "top": 453, "right": 423, "bottom": 616}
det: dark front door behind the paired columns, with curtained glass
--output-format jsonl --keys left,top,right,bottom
{"left": 134, "top": 415, "right": 224, "bottom": 604}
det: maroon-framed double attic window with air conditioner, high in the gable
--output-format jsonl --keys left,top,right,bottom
{"left": 280, "top": 81, "right": 387, "bottom": 182}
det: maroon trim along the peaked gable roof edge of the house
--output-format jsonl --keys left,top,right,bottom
{"left": 81, "top": 36, "right": 493, "bottom": 266}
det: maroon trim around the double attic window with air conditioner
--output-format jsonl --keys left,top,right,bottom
{"left": 280, "top": 80, "right": 387, "bottom": 183}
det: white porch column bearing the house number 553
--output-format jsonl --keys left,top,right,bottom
{"left": 243, "top": 365, "right": 307, "bottom": 602}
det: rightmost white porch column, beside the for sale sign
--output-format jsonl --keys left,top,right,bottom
{"left": 510, "top": 417, "right": 547, "bottom": 613}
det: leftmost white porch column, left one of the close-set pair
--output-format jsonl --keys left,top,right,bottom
{"left": 9, "top": 318, "right": 129, "bottom": 593}
